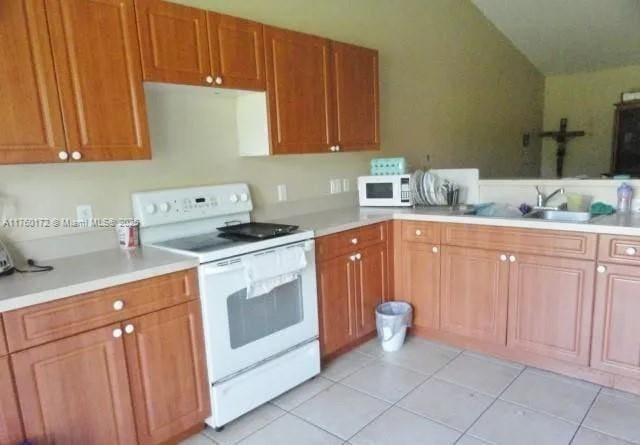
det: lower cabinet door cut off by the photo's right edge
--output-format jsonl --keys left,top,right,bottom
{"left": 591, "top": 264, "right": 640, "bottom": 378}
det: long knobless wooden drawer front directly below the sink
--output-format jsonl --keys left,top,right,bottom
{"left": 442, "top": 224, "right": 597, "bottom": 260}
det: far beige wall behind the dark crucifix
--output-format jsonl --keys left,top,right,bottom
{"left": 541, "top": 65, "right": 640, "bottom": 178}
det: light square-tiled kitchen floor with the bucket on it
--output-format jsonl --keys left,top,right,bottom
{"left": 183, "top": 338, "right": 640, "bottom": 445}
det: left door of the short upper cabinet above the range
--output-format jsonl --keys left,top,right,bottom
{"left": 135, "top": 0, "right": 213, "bottom": 85}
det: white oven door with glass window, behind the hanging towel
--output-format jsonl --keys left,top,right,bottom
{"left": 199, "top": 240, "right": 318, "bottom": 383}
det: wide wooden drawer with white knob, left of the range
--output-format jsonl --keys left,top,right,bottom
{"left": 3, "top": 269, "right": 198, "bottom": 352}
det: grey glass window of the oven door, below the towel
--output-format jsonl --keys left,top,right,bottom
{"left": 227, "top": 276, "right": 304, "bottom": 349}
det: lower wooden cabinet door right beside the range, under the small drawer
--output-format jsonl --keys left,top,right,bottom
{"left": 317, "top": 251, "right": 356, "bottom": 356}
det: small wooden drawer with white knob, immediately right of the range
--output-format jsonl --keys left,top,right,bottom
{"left": 316, "top": 223, "right": 387, "bottom": 260}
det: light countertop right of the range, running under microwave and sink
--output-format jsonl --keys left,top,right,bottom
{"left": 277, "top": 207, "right": 640, "bottom": 236}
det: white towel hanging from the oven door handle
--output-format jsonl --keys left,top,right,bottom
{"left": 242, "top": 246, "right": 307, "bottom": 298}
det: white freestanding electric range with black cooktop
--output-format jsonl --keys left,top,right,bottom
{"left": 132, "top": 184, "right": 320, "bottom": 428}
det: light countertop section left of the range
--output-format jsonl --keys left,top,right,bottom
{"left": 0, "top": 247, "right": 198, "bottom": 312}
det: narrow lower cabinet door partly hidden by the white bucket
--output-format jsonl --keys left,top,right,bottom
{"left": 356, "top": 244, "right": 389, "bottom": 337}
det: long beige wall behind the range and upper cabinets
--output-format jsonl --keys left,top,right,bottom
{"left": 0, "top": 0, "right": 544, "bottom": 240}
